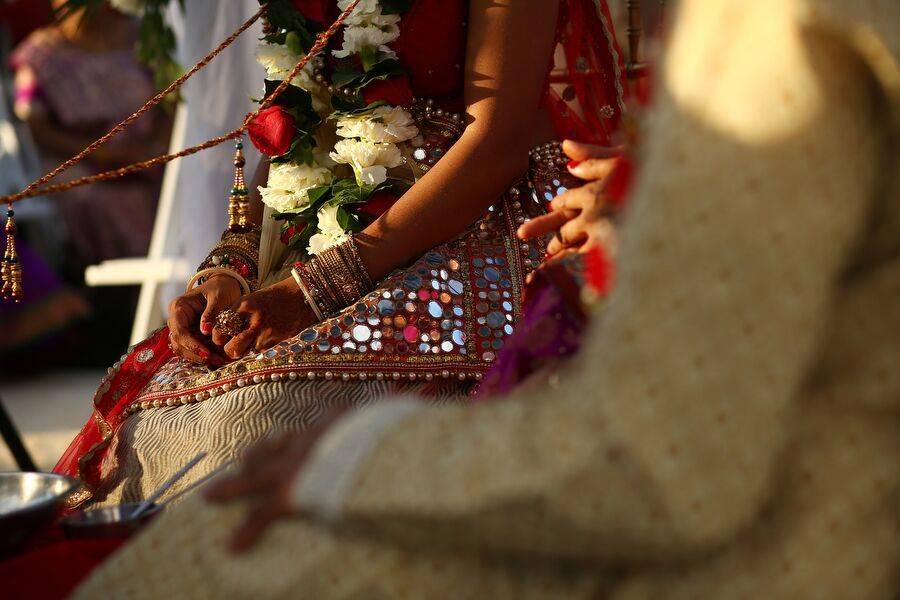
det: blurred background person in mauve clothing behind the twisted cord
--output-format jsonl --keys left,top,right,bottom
{"left": 11, "top": 0, "right": 170, "bottom": 271}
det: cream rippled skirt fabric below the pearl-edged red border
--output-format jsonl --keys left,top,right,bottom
{"left": 91, "top": 380, "right": 471, "bottom": 506}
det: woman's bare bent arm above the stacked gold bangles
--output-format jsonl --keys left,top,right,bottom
{"left": 357, "top": 0, "right": 558, "bottom": 281}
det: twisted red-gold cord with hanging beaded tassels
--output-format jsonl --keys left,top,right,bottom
{"left": 0, "top": 0, "right": 361, "bottom": 302}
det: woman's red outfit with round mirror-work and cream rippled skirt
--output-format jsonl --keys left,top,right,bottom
{"left": 55, "top": 0, "right": 624, "bottom": 506}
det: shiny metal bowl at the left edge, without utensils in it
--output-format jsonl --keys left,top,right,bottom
{"left": 0, "top": 472, "right": 81, "bottom": 555}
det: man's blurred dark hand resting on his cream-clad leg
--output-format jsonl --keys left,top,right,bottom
{"left": 204, "top": 406, "right": 349, "bottom": 552}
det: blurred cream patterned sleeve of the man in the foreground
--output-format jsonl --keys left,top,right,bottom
{"left": 299, "top": 0, "right": 883, "bottom": 560}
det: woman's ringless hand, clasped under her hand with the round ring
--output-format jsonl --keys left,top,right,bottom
{"left": 168, "top": 275, "right": 241, "bottom": 366}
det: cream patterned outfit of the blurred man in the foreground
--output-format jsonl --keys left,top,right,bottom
{"left": 74, "top": 0, "right": 900, "bottom": 600}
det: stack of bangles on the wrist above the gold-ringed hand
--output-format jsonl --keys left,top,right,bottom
{"left": 291, "top": 238, "right": 375, "bottom": 321}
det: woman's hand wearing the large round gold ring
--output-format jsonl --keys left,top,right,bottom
{"left": 212, "top": 277, "right": 317, "bottom": 360}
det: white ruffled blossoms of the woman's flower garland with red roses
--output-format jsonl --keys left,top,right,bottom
{"left": 256, "top": 0, "right": 419, "bottom": 255}
